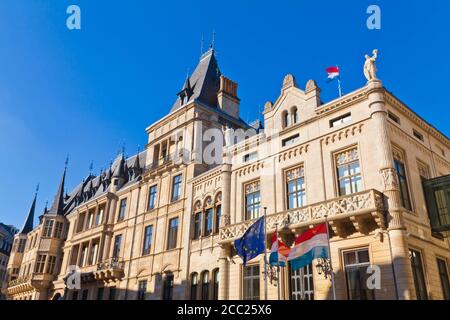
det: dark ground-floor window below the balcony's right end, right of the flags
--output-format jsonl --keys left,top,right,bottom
{"left": 344, "top": 249, "right": 375, "bottom": 300}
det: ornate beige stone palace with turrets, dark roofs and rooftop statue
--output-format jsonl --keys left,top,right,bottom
{"left": 7, "top": 49, "right": 450, "bottom": 300}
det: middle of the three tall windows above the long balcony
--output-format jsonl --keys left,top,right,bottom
{"left": 286, "top": 167, "right": 306, "bottom": 209}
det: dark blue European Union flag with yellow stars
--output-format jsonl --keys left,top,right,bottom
{"left": 234, "top": 217, "right": 266, "bottom": 266}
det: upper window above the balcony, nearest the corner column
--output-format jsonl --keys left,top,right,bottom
{"left": 336, "top": 149, "right": 362, "bottom": 196}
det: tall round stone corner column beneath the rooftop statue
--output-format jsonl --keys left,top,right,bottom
{"left": 368, "top": 80, "right": 415, "bottom": 300}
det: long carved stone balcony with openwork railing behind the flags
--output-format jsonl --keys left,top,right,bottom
{"left": 219, "top": 190, "right": 385, "bottom": 243}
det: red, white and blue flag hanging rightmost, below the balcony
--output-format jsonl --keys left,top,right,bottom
{"left": 288, "top": 223, "right": 329, "bottom": 270}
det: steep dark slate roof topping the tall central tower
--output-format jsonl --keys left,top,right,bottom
{"left": 170, "top": 48, "right": 220, "bottom": 112}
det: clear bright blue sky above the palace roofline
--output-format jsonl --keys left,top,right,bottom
{"left": 0, "top": 0, "right": 450, "bottom": 227}
